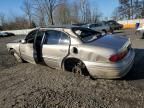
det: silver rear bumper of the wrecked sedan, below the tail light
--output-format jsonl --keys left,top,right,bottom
{"left": 84, "top": 50, "right": 135, "bottom": 79}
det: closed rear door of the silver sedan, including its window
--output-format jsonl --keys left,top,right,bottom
{"left": 42, "top": 30, "right": 70, "bottom": 68}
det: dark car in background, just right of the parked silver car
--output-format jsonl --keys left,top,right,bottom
{"left": 106, "top": 20, "right": 123, "bottom": 30}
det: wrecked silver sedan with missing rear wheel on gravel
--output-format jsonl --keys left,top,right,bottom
{"left": 7, "top": 26, "right": 135, "bottom": 79}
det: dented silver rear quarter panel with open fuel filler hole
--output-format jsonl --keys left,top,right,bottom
{"left": 69, "top": 44, "right": 114, "bottom": 62}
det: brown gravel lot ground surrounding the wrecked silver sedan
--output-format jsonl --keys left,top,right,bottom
{"left": 0, "top": 30, "right": 144, "bottom": 108}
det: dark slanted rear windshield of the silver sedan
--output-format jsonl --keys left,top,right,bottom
{"left": 72, "top": 28, "right": 101, "bottom": 42}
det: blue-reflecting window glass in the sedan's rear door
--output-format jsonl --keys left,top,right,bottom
{"left": 45, "top": 30, "right": 69, "bottom": 45}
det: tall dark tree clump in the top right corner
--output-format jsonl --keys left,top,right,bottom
{"left": 116, "top": 0, "right": 144, "bottom": 19}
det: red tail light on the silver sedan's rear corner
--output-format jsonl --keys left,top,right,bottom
{"left": 109, "top": 51, "right": 128, "bottom": 62}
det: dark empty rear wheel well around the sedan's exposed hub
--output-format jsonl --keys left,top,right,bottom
{"left": 63, "top": 58, "right": 89, "bottom": 76}
